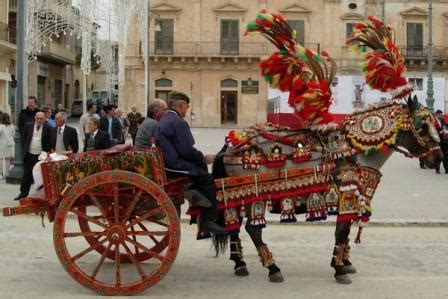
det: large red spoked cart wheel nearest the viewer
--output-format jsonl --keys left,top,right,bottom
{"left": 53, "top": 170, "right": 180, "bottom": 295}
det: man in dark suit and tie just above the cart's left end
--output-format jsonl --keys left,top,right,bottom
{"left": 53, "top": 112, "right": 78, "bottom": 154}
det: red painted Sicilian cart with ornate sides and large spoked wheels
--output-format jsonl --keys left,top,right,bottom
{"left": 3, "top": 146, "right": 187, "bottom": 295}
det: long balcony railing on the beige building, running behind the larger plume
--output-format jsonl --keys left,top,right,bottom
{"left": 145, "top": 41, "right": 318, "bottom": 57}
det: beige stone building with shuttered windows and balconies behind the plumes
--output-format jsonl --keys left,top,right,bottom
{"left": 120, "top": 0, "right": 448, "bottom": 127}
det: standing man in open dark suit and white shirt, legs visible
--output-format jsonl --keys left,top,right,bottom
{"left": 15, "top": 112, "right": 54, "bottom": 200}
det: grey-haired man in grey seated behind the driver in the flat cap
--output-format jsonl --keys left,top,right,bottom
{"left": 135, "top": 99, "right": 167, "bottom": 149}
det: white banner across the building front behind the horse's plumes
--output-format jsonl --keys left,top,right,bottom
{"left": 268, "top": 76, "right": 445, "bottom": 114}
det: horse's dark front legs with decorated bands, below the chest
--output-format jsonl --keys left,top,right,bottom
{"left": 331, "top": 221, "right": 356, "bottom": 284}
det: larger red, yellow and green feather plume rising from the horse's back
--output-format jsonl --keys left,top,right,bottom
{"left": 246, "top": 10, "right": 336, "bottom": 126}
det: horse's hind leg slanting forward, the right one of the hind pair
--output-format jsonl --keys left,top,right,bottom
{"left": 245, "top": 225, "right": 284, "bottom": 282}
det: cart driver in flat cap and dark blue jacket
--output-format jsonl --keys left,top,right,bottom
{"left": 155, "top": 92, "right": 227, "bottom": 237}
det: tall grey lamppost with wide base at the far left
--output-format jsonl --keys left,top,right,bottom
{"left": 6, "top": 0, "right": 28, "bottom": 184}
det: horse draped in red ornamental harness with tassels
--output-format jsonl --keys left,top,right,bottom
{"left": 207, "top": 97, "right": 442, "bottom": 284}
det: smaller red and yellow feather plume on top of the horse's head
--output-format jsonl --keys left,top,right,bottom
{"left": 346, "top": 17, "right": 413, "bottom": 99}
